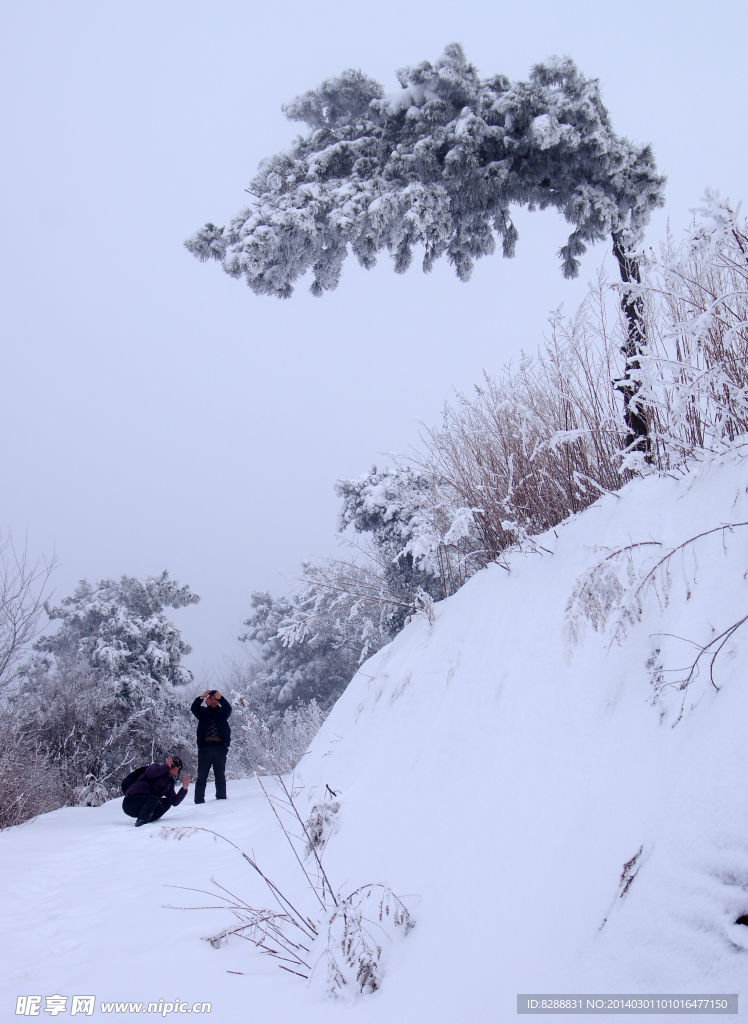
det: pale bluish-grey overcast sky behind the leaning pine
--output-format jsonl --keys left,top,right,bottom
{"left": 0, "top": 0, "right": 748, "bottom": 678}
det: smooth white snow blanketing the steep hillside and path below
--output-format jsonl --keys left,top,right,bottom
{"left": 0, "top": 447, "right": 748, "bottom": 1024}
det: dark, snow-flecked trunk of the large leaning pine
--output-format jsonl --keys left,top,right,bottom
{"left": 613, "top": 233, "right": 652, "bottom": 462}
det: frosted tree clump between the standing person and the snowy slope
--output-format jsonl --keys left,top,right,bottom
{"left": 233, "top": 465, "right": 487, "bottom": 721}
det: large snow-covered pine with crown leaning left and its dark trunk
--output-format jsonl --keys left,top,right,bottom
{"left": 186, "top": 44, "right": 664, "bottom": 446}
